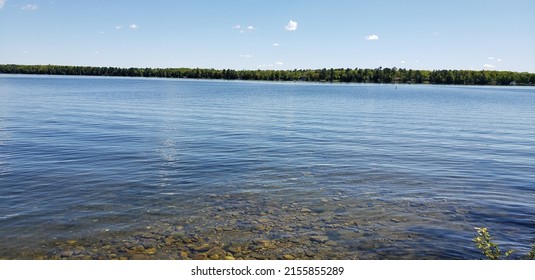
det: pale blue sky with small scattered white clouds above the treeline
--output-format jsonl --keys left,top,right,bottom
{"left": 0, "top": 0, "right": 535, "bottom": 72}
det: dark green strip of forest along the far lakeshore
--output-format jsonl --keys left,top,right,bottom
{"left": 0, "top": 64, "right": 535, "bottom": 85}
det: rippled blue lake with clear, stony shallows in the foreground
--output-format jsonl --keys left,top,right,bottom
{"left": 0, "top": 75, "right": 535, "bottom": 259}
